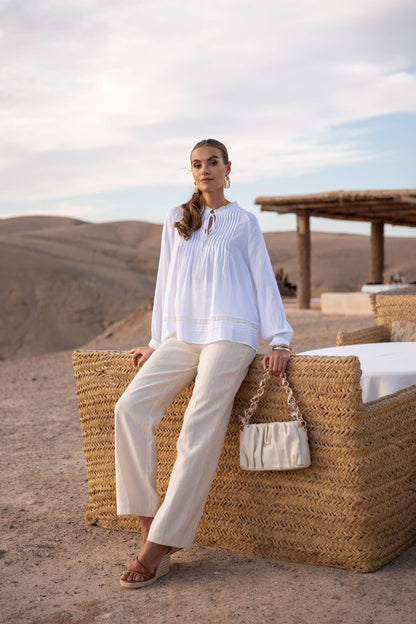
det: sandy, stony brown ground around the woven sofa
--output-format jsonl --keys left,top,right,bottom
{"left": 0, "top": 311, "right": 416, "bottom": 624}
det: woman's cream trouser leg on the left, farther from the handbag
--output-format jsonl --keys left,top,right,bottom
{"left": 115, "top": 338, "right": 200, "bottom": 518}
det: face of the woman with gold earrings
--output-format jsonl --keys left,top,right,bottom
{"left": 191, "top": 145, "right": 231, "bottom": 193}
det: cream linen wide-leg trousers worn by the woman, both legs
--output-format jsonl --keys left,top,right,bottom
{"left": 115, "top": 337, "right": 256, "bottom": 548}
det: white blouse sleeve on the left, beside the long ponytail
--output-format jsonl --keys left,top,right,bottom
{"left": 149, "top": 214, "right": 175, "bottom": 349}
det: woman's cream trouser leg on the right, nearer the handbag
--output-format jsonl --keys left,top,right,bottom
{"left": 148, "top": 341, "right": 255, "bottom": 547}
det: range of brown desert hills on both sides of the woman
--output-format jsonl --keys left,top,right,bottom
{"left": 0, "top": 216, "right": 416, "bottom": 358}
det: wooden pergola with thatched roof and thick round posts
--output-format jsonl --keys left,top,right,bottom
{"left": 255, "top": 189, "right": 416, "bottom": 308}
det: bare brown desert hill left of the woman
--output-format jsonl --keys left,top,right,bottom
{"left": 0, "top": 217, "right": 161, "bottom": 357}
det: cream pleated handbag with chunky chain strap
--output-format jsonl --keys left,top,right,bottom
{"left": 240, "top": 370, "right": 311, "bottom": 470}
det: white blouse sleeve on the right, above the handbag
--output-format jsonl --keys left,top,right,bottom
{"left": 248, "top": 215, "right": 293, "bottom": 347}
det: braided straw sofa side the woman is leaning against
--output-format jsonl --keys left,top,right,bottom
{"left": 73, "top": 351, "right": 416, "bottom": 572}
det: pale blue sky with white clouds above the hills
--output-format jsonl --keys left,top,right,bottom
{"left": 0, "top": 0, "right": 416, "bottom": 236}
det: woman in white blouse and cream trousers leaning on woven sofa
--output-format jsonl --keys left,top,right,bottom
{"left": 115, "top": 139, "right": 292, "bottom": 588}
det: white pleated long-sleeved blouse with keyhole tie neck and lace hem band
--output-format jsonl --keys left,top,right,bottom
{"left": 149, "top": 202, "right": 293, "bottom": 349}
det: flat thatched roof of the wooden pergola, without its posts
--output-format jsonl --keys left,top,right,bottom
{"left": 255, "top": 189, "right": 416, "bottom": 227}
